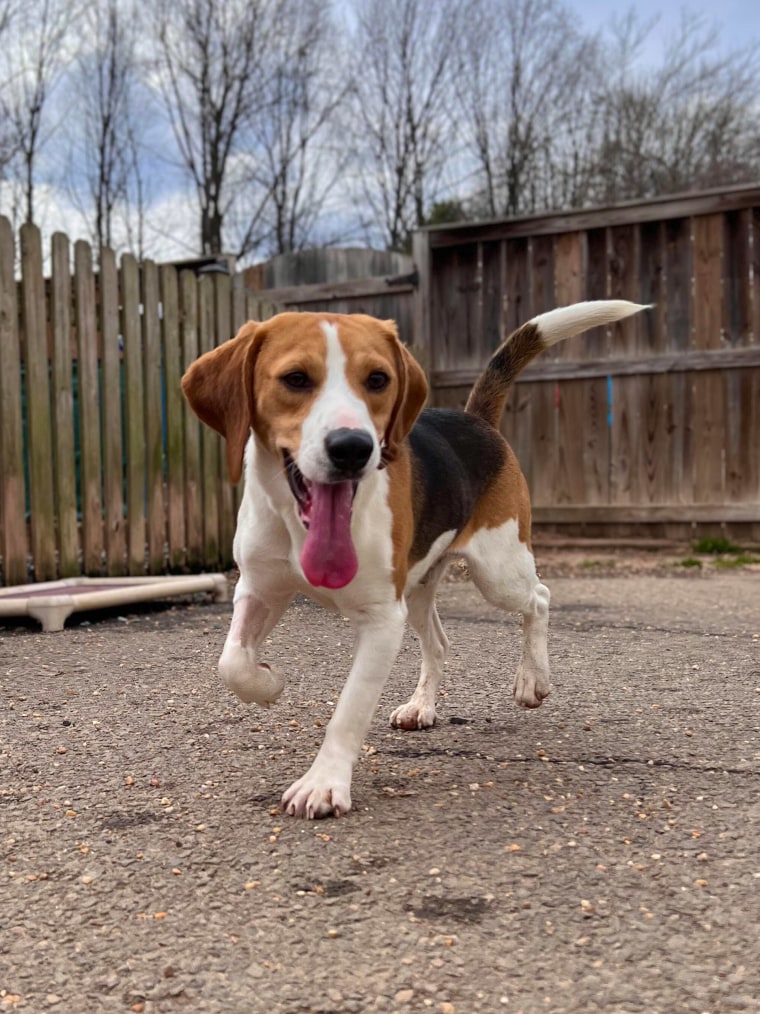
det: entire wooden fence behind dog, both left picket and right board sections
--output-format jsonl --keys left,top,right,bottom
{"left": 0, "top": 188, "right": 760, "bottom": 584}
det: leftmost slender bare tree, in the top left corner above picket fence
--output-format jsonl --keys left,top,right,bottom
{"left": 6, "top": 0, "right": 71, "bottom": 222}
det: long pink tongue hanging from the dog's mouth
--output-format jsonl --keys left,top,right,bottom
{"left": 301, "top": 482, "right": 359, "bottom": 588}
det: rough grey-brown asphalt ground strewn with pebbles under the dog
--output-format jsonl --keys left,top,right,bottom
{"left": 0, "top": 571, "right": 760, "bottom": 1014}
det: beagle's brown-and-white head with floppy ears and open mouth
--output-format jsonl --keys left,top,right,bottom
{"left": 182, "top": 313, "right": 428, "bottom": 587}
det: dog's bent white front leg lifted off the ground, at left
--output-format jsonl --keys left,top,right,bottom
{"left": 219, "top": 592, "right": 292, "bottom": 708}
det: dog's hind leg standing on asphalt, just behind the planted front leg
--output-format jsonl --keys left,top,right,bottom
{"left": 390, "top": 558, "right": 449, "bottom": 729}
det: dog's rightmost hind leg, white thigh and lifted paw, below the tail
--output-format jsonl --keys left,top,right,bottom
{"left": 461, "top": 520, "right": 550, "bottom": 708}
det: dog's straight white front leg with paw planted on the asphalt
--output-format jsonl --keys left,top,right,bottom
{"left": 283, "top": 601, "right": 406, "bottom": 820}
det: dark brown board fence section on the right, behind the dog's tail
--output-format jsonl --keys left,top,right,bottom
{"left": 414, "top": 188, "right": 760, "bottom": 539}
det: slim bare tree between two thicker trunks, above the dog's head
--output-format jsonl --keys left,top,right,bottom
{"left": 235, "top": 0, "right": 348, "bottom": 257}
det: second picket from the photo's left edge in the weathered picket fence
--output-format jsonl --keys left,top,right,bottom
{"left": 20, "top": 223, "right": 56, "bottom": 581}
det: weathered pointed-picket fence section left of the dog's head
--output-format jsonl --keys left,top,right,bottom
{"left": 0, "top": 218, "right": 279, "bottom": 584}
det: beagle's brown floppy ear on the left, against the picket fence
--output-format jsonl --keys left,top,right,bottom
{"left": 182, "top": 320, "right": 260, "bottom": 483}
